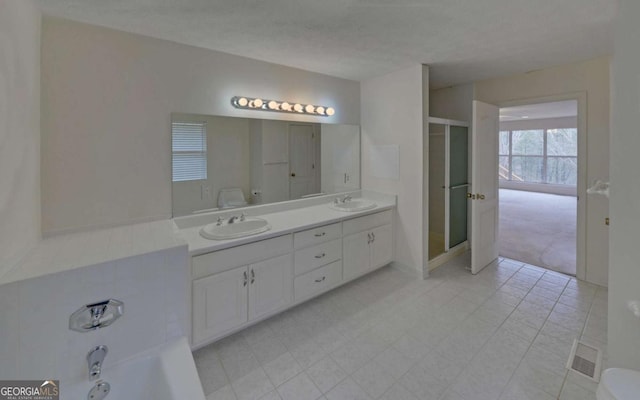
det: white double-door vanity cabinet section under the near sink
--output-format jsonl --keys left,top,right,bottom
{"left": 192, "top": 235, "right": 293, "bottom": 345}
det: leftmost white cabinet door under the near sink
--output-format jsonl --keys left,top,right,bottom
{"left": 193, "top": 267, "right": 248, "bottom": 344}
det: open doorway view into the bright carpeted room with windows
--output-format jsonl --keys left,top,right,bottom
{"left": 497, "top": 99, "right": 579, "bottom": 276}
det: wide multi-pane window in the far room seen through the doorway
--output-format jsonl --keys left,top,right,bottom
{"left": 498, "top": 128, "right": 578, "bottom": 185}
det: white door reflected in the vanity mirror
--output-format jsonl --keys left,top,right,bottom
{"left": 289, "top": 124, "right": 320, "bottom": 200}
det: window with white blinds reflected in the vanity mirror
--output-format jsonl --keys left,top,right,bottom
{"left": 171, "top": 122, "right": 207, "bottom": 182}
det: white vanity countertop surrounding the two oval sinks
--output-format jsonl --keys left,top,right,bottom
{"left": 180, "top": 196, "right": 396, "bottom": 256}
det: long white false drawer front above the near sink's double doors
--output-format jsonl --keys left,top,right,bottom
{"left": 191, "top": 235, "right": 292, "bottom": 279}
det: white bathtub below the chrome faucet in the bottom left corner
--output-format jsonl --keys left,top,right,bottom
{"left": 60, "top": 337, "right": 205, "bottom": 400}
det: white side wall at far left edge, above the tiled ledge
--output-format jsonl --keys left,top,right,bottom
{"left": 0, "top": 0, "right": 41, "bottom": 276}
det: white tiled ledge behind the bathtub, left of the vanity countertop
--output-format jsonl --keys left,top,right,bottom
{"left": 0, "top": 220, "right": 187, "bottom": 285}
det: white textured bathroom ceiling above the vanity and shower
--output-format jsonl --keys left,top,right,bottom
{"left": 37, "top": 0, "right": 616, "bottom": 87}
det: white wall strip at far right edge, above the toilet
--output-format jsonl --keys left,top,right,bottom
{"left": 607, "top": 0, "right": 640, "bottom": 370}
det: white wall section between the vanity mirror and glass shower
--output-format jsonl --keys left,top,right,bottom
{"left": 361, "top": 65, "right": 429, "bottom": 276}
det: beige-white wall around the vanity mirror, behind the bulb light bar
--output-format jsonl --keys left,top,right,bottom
{"left": 42, "top": 18, "right": 360, "bottom": 234}
